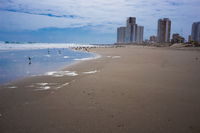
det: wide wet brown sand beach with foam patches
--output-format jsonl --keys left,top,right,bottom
{"left": 0, "top": 45, "right": 200, "bottom": 133}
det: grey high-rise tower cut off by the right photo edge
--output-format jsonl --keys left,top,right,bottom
{"left": 191, "top": 22, "right": 200, "bottom": 42}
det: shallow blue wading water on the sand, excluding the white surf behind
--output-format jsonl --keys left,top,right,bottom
{"left": 0, "top": 48, "right": 99, "bottom": 85}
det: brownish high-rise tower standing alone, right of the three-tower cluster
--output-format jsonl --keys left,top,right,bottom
{"left": 157, "top": 18, "right": 171, "bottom": 43}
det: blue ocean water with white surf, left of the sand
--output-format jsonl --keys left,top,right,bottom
{"left": 0, "top": 43, "right": 98, "bottom": 84}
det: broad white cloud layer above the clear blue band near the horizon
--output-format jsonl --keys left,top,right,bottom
{"left": 0, "top": 0, "right": 200, "bottom": 38}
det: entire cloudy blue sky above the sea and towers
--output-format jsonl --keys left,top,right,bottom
{"left": 0, "top": 0, "right": 200, "bottom": 44}
